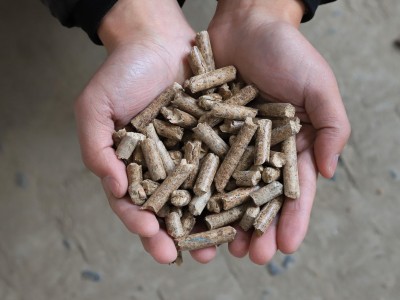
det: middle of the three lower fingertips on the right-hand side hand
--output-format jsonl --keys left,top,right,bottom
{"left": 249, "top": 218, "right": 277, "bottom": 265}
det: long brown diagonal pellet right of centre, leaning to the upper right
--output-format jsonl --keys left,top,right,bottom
{"left": 214, "top": 118, "right": 257, "bottom": 192}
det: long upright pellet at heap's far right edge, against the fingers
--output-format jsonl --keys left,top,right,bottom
{"left": 282, "top": 136, "right": 300, "bottom": 199}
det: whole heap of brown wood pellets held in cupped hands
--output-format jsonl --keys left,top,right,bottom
{"left": 113, "top": 31, "right": 301, "bottom": 260}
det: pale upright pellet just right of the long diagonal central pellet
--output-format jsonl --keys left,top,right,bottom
{"left": 254, "top": 119, "right": 272, "bottom": 165}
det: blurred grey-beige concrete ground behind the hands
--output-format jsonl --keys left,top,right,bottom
{"left": 0, "top": 0, "right": 400, "bottom": 300}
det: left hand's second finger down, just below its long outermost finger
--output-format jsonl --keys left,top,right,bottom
{"left": 103, "top": 179, "right": 160, "bottom": 237}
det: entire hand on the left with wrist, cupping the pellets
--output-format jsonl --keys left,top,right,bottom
{"left": 75, "top": 0, "right": 215, "bottom": 263}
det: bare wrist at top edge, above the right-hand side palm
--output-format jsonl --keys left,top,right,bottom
{"left": 216, "top": 0, "right": 305, "bottom": 28}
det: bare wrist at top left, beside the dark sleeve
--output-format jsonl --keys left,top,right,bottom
{"left": 98, "top": 0, "right": 191, "bottom": 52}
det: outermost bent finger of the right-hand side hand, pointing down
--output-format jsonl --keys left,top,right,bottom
{"left": 305, "top": 63, "right": 350, "bottom": 178}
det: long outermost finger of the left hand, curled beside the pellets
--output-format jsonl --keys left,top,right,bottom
{"left": 75, "top": 91, "right": 128, "bottom": 198}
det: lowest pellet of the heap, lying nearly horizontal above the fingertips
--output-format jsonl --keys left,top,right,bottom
{"left": 176, "top": 226, "right": 236, "bottom": 251}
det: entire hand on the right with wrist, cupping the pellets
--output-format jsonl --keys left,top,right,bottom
{"left": 208, "top": 0, "right": 350, "bottom": 264}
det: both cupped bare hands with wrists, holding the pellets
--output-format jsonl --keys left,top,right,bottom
{"left": 75, "top": 0, "right": 350, "bottom": 264}
